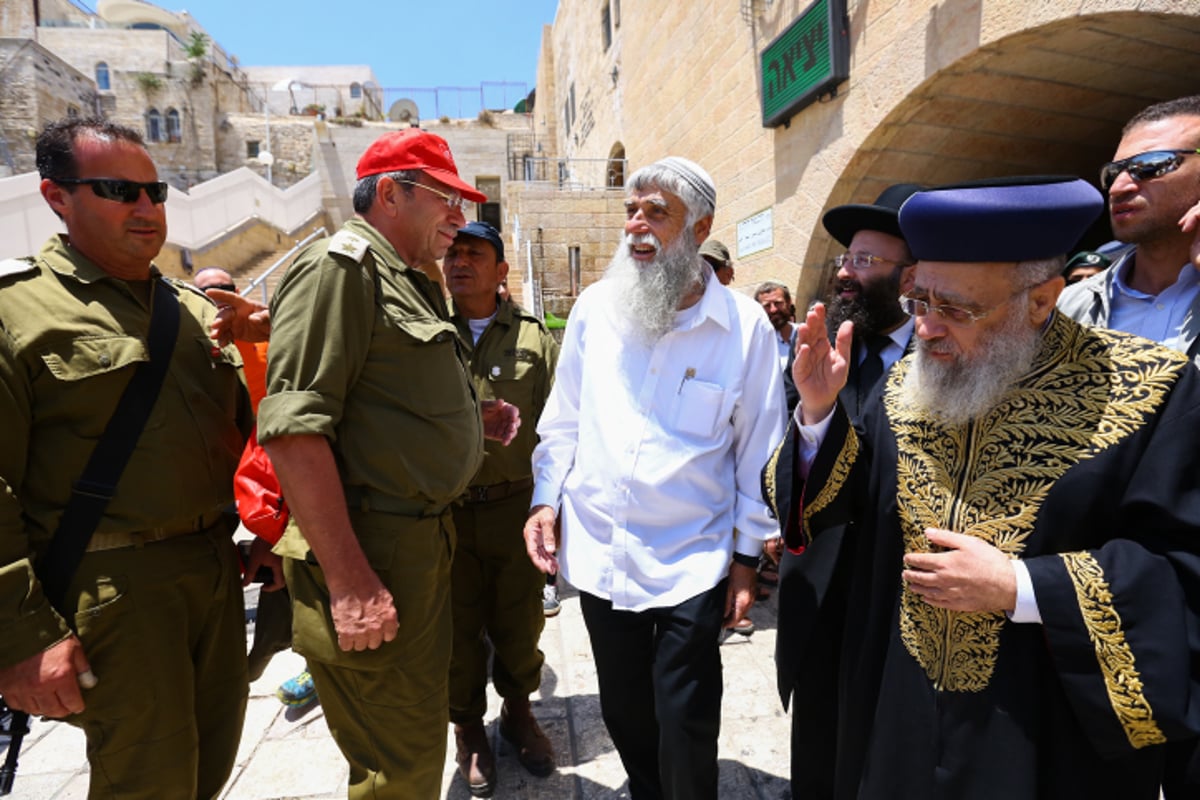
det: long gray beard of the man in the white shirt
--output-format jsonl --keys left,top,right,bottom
{"left": 604, "top": 230, "right": 704, "bottom": 344}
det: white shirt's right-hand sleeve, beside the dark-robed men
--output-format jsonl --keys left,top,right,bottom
{"left": 733, "top": 311, "right": 784, "bottom": 555}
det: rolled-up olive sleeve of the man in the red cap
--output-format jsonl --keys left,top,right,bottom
{"left": 258, "top": 250, "right": 374, "bottom": 441}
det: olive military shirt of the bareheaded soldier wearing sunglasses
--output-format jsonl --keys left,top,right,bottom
{"left": 0, "top": 236, "right": 253, "bottom": 668}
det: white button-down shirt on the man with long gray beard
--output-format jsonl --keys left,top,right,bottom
{"left": 533, "top": 275, "right": 785, "bottom": 610}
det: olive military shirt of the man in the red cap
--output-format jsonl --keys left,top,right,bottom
{"left": 258, "top": 218, "right": 484, "bottom": 505}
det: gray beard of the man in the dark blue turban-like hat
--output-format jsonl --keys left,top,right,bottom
{"left": 901, "top": 294, "right": 1042, "bottom": 425}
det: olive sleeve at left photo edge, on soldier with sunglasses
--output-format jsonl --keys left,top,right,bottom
{"left": 0, "top": 321, "right": 70, "bottom": 669}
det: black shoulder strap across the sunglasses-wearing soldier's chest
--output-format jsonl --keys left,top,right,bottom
{"left": 37, "top": 279, "right": 179, "bottom": 612}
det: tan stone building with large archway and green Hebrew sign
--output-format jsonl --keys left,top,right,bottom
{"left": 509, "top": 0, "right": 1200, "bottom": 302}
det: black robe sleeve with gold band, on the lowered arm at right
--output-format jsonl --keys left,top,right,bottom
{"left": 1026, "top": 381, "right": 1200, "bottom": 757}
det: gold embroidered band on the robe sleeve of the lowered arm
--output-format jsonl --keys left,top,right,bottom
{"left": 1062, "top": 553, "right": 1166, "bottom": 747}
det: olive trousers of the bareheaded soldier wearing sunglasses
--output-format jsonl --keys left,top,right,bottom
{"left": 66, "top": 521, "right": 247, "bottom": 800}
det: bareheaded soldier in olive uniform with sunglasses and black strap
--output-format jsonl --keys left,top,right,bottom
{"left": 0, "top": 119, "right": 263, "bottom": 799}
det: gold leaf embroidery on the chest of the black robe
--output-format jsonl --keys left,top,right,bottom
{"left": 884, "top": 317, "right": 1190, "bottom": 692}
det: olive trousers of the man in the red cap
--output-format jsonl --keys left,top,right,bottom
{"left": 283, "top": 507, "right": 455, "bottom": 800}
